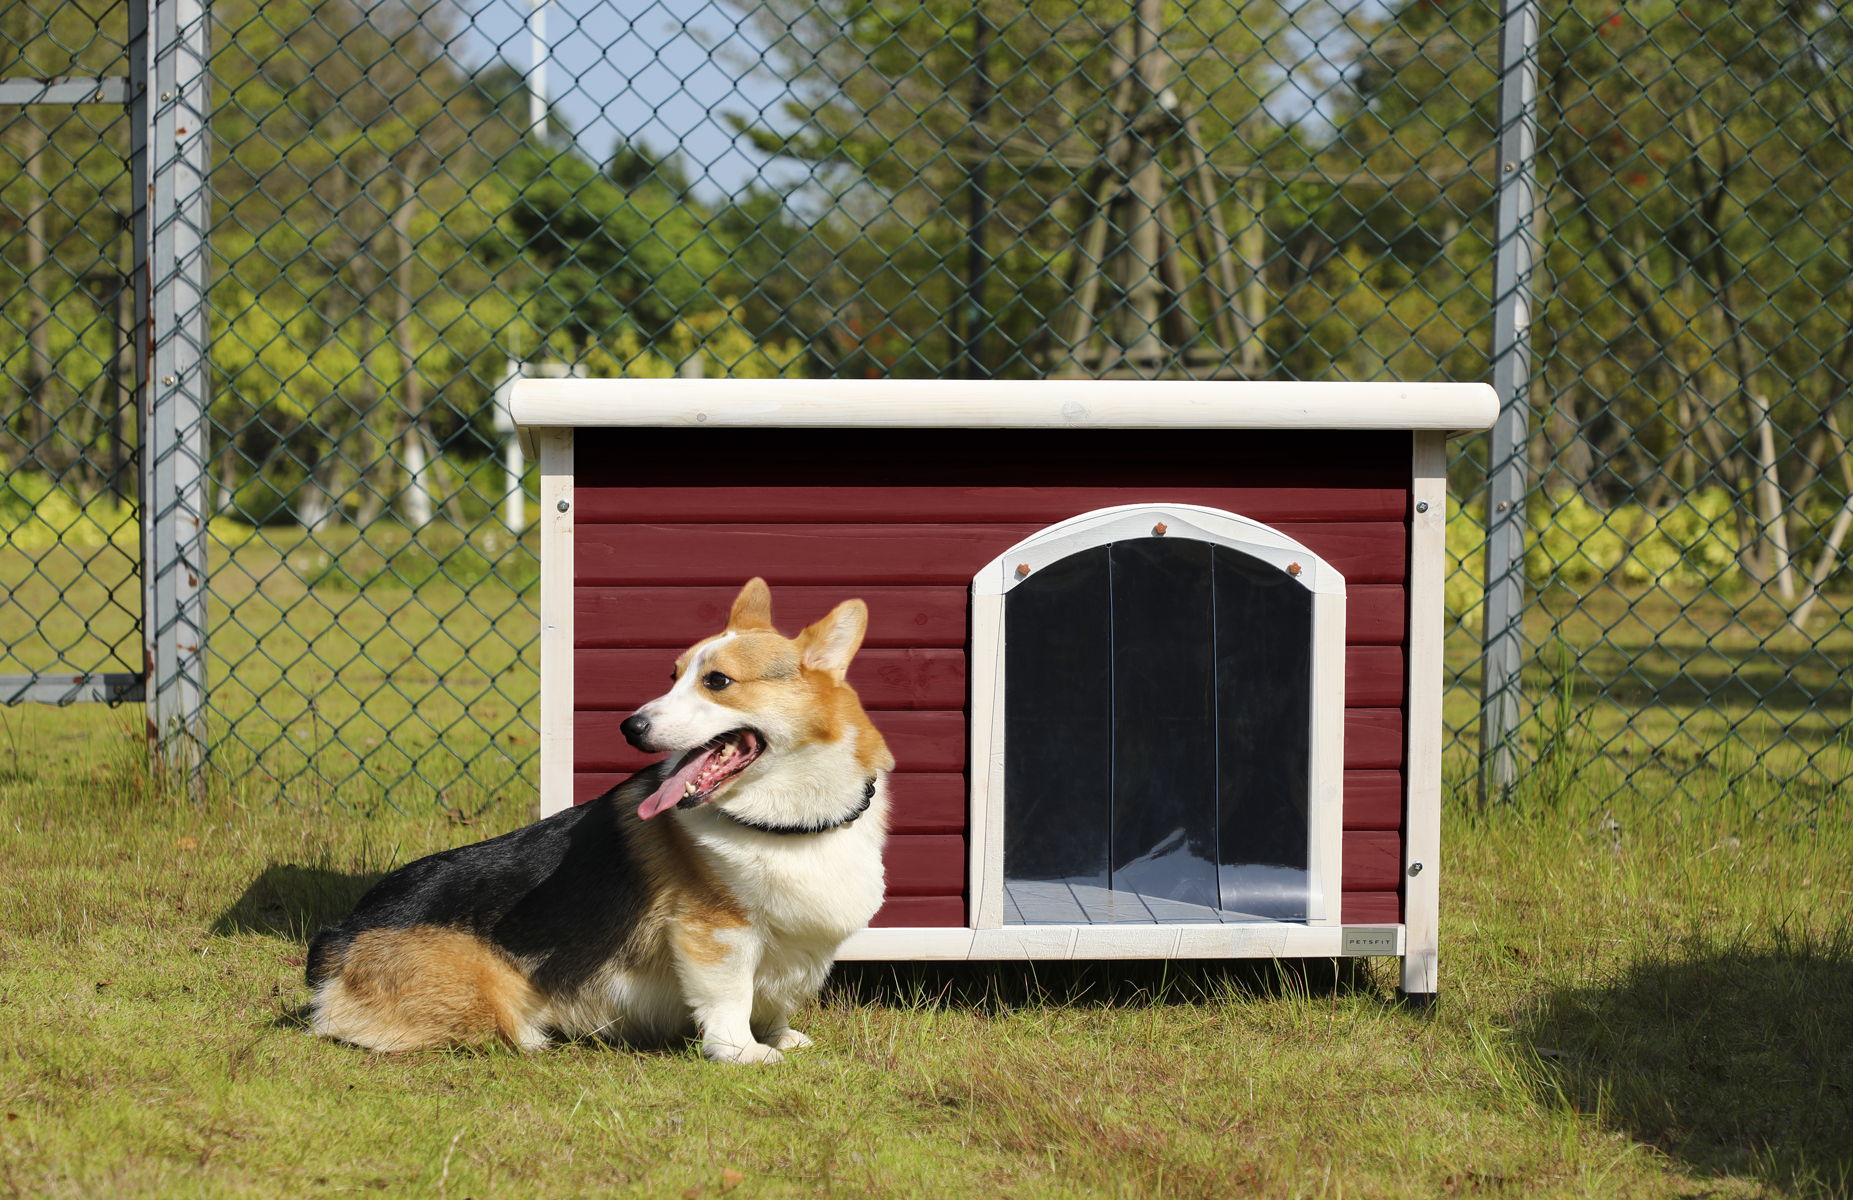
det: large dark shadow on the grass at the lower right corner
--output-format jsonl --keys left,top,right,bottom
{"left": 1519, "top": 931, "right": 1853, "bottom": 1196}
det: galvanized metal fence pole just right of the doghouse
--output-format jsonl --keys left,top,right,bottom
{"left": 1481, "top": 0, "right": 1538, "bottom": 804}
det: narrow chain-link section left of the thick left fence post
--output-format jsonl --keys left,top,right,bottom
{"left": 0, "top": 4, "right": 143, "bottom": 702}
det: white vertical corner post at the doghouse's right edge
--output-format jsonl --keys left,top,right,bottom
{"left": 1403, "top": 433, "right": 1447, "bottom": 993}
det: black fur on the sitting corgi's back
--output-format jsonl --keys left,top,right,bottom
{"left": 304, "top": 763, "right": 667, "bottom": 993}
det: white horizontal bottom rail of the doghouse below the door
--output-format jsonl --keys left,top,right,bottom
{"left": 836, "top": 920, "right": 1405, "bottom": 963}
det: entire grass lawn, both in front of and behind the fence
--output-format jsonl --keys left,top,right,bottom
{"left": 0, "top": 514, "right": 1853, "bottom": 1198}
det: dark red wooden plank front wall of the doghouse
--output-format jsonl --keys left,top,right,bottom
{"left": 574, "top": 430, "right": 1408, "bottom": 926}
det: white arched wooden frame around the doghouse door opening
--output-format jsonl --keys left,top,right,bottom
{"left": 967, "top": 504, "right": 1345, "bottom": 931}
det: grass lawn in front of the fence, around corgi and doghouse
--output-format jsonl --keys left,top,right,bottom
{"left": 0, "top": 707, "right": 1853, "bottom": 1198}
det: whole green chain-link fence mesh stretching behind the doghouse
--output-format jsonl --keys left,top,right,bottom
{"left": 0, "top": 0, "right": 1853, "bottom": 817}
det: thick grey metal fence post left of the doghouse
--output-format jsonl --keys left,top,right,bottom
{"left": 130, "top": 0, "right": 211, "bottom": 789}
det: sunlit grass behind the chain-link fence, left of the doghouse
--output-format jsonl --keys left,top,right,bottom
{"left": 0, "top": 522, "right": 539, "bottom": 813}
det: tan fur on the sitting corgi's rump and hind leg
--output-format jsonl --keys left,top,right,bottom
{"left": 315, "top": 926, "right": 539, "bottom": 1050}
